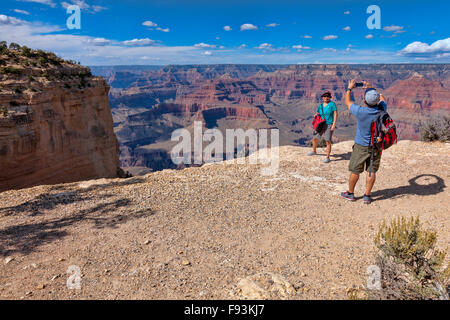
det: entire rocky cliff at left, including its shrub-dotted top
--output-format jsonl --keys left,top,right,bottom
{"left": 0, "top": 44, "right": 119, "bottom": 191}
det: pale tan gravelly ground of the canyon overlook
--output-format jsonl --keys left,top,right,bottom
{"left": 0, "top": 141, "right": 450, "bottom": 299}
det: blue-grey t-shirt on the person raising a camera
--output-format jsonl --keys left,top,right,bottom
{"left": 350, "top": 101, "right": 387, "bottom": 147}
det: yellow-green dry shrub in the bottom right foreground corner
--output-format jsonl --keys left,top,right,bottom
{"left": 356, "top": 217, "right": 450, "bottom": 300}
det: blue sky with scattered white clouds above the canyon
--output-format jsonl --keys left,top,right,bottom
{"left": 0, "top": 0, "right": 450, "bottom": 65}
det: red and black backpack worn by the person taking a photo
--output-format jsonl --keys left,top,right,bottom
{"left": 369, "top": 107, "right": 397, "bottom": 176}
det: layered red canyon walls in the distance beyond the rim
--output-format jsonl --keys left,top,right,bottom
{"left": 91, "top": 64, "right": 450, "bottom": 174}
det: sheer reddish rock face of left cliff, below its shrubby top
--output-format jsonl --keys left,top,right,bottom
{"left": 0, "top": 78, "right": 119, "bottom": 191}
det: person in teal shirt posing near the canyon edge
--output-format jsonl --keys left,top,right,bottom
{"left": 308, "top": 91, "right": 337, "bottom": 163}
